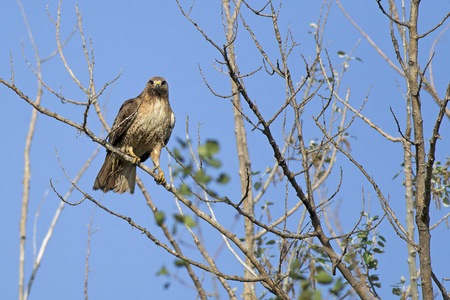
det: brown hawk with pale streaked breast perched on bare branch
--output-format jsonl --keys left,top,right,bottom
{"left": 93, "top": 77, "right": 175, "bottom": 194}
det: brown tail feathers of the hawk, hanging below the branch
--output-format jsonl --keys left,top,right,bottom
{"left": 93, "top": 153, "right": 136, "bottom": 194}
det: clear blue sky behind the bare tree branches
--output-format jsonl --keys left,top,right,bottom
{"left": 0, "top": 0, "right": 450, "bottom": 299}
